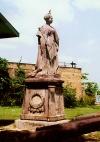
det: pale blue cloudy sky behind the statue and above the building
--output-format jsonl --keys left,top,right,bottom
{"left": 0, "top": 0, "right": 100, "bottom": 83}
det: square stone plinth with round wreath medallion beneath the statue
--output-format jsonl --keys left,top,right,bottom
{"left": 21, "top": 75, "right": 64, "bottom": 121}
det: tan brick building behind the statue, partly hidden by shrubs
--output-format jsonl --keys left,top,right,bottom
{"left": 8, "top": 62, "right": 83, "bottom": 99}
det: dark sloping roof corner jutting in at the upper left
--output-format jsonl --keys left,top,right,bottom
{"left": 0, "top": 13, "right": 19, "bottom": 38}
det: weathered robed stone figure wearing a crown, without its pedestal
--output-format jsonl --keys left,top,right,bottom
{"left": 27, "top": 11, "right": 59, "bottom": 77}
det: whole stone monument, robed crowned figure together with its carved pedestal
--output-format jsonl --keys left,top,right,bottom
{"left": 18, "top": 11, "right": 64, "bottom": 123}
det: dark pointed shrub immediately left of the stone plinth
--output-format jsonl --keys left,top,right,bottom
{"left": 10, "top": 62, "right": 25, "bottom": 105}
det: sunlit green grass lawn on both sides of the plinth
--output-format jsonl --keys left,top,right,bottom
{"left": 0, "top": 106, "right": 100, "bottom": 120}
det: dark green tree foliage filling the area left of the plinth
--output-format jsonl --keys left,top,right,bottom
{"left": 0, "top": 58, "right": 25, "bottom": 106}
